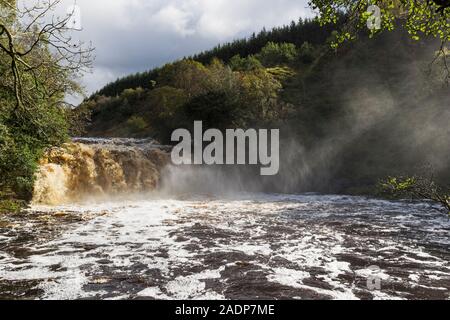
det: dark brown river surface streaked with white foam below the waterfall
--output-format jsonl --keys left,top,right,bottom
{"left": 0, "top": 194, "right": 450, "bottom": 299}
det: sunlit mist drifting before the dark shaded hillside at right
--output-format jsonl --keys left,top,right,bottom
{"left": 266, "top": 33, "right": 450, "bottom": 193}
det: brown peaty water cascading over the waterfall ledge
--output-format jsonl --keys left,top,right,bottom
{"left": 33, "top": 139, "right": 169, "bottom": 205}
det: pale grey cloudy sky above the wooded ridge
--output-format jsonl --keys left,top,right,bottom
{"left": 51, "top": 0, "right": 312, "bottom": 100}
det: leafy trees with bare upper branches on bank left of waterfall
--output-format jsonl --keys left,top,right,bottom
{"left": 0, "top": 0, "right": 93, "bottom": 198}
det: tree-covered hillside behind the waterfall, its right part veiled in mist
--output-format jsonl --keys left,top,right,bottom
{"left": 79, "top": 21, "right": 450, "bottom": 193}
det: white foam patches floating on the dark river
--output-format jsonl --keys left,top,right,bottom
{"left": 0, "top": 194, "right": 450, "bottom": 299}
